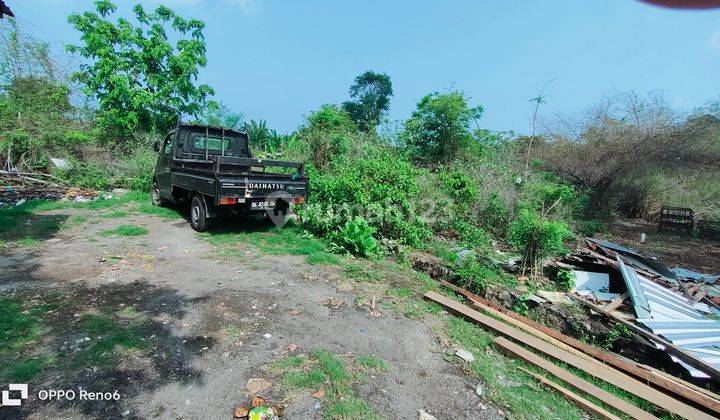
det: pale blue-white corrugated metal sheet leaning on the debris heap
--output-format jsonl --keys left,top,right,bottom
{"left": 618, "top": 259, "right": 720, "bottom": 378}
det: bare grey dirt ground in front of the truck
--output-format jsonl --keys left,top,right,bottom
{"left": 0, "top": 210, "right": 500, "bottom": 419}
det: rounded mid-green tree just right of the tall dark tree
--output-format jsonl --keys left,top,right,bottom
{"left": 401, "top": 91, "right": 483, "bottom": 163}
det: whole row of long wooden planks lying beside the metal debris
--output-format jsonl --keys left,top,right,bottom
{"left": 425, "top": 282, "right": 720, "bottom": 419}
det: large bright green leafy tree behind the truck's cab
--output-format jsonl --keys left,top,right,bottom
{"left": 67, "top": 0, "right": 213, "bottom": 136}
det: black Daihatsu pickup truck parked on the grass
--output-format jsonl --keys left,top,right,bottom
{"left": 152, "top": 124, "right": 308, "bottom": 232}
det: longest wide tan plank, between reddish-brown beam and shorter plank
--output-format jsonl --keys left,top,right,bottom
{"left": 425, "top": 292, "right": 713, "bottom": 420}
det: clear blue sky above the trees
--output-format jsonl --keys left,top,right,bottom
{"left": 6, "top": 0, "right": 720, "bottom": 133}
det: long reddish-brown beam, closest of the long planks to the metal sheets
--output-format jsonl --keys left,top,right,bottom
{"left": 441, "top": 281, "right": 720, "bottom": 414}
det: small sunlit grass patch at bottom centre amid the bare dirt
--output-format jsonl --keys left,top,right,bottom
{"left": 271, "top": 349, "right": 380, "bottom": 419}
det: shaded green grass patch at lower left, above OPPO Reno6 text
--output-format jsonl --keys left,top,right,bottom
{"left": 0, "top": 291, "right": 151, "bottom": 383}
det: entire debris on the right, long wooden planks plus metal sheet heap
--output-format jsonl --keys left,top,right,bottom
{"left": 425, "top": 238, "right": 720, "bottom": 419}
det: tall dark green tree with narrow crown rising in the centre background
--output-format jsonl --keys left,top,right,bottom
{"left": 343, "top": 71, "right": 393, "bottom": 132}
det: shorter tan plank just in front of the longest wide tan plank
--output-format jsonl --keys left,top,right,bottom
{"left": 493, "top": 337, "right": 657, "bottom": 420}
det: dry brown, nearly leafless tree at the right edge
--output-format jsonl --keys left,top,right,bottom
{"left": 533, "top": 92, "right": 720, "bottom": 217}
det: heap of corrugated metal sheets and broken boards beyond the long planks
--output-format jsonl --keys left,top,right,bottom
{"left": 557, "top": 238, "right": 720, "bottom": 379}
